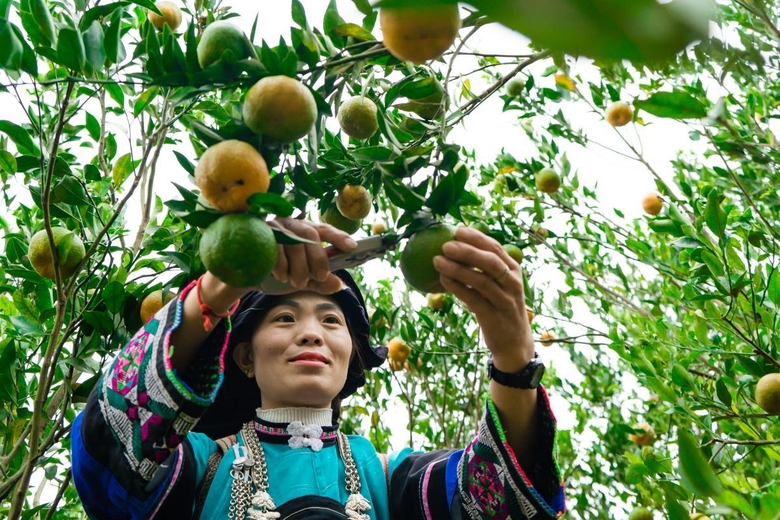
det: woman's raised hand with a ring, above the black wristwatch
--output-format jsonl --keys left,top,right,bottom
{"left": 433, "top": 227, "right": 534, "bottom": 370}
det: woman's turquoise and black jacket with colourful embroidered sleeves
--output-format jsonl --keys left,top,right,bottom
{"left": 71, "top": 284, "right": 565, "bottom": 520}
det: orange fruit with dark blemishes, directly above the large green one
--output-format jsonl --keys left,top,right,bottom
{"left": 195, "top": 139, "right": 271, "bottom": 213}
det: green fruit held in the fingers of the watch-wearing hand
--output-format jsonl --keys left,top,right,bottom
{"left": 401, "top": 224, "right": 455, "bottom": 293}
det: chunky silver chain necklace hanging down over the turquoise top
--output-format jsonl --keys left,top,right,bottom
{"left": 228, "top": 421, "right": 371, "bottom": 520}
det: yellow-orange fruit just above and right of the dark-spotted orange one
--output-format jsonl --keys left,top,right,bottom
{"left": 242, "top": 76, "right": 317, "bottom": 143}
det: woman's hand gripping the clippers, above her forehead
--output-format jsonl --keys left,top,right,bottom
{"left": 257, "top": 217, "right": 357, "bottom": 294}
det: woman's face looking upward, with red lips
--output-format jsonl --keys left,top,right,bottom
{"left": 248, "top": 292, "right": 352, "bottom": 409}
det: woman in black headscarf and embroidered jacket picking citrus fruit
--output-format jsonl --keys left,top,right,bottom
{"left": 72, "top": 219, "right": 565, "bottom": 520}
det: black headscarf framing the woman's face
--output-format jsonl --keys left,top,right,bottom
{"left": 194, "top": 270, "right": 387, "bottom": 439}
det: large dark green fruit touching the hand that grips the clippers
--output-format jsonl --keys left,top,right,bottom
{"left": 200, "top": 213, "right": 278, "bottom": 288}
